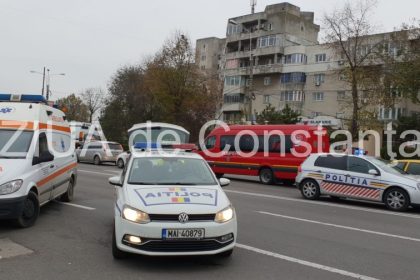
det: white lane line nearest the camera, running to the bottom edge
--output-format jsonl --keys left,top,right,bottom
{"left": 236, "top": 244, "right": 378, "bottom": 280}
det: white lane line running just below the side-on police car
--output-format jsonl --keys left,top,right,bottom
{"left": 224, "top": 190, "right": 420, "bottom": 219}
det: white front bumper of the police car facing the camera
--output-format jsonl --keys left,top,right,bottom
{"left": 115, "top": 216, "right": 237, "bottom": 256}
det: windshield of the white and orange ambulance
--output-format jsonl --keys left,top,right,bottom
{"left": 0, "top": 130, "right": 33, "bottom": 158}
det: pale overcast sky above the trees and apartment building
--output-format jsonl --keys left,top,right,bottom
{"left": 0, "top": 0, "right": 420, "bottom": 99}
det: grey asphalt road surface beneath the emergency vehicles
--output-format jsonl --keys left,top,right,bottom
{"left": 0, "top": 164, "right": 420, "bottom": 280}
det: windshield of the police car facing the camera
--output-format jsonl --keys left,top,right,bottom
{"left": 128, "top": 157, "right": 217, "bottom": 185}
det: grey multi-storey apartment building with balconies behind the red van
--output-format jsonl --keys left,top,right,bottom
{"left": 196, "top": 3, "right": 420, "bottom": 127}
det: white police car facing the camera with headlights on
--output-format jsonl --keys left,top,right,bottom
{"left": 109, "top": 144, "right": 237, "bottom": 259}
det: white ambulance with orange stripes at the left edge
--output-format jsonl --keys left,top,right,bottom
{"left": 0, "top": 94, "right": 77, "bottom": 228}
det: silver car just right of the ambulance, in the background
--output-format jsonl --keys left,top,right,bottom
{"left": 76, "top": 141, "right": 123, "bottom": 165}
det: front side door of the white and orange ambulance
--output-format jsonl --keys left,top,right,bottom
{"left": 34, "top": 132, "right": 55, "bottom": 204}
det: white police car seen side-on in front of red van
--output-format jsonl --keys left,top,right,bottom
{"left": 296, "top": 154, "right": 420, "bottom": 211}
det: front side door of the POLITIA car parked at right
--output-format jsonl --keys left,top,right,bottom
{"left": 345, "top": 156, "right": 384, "bottom": 201}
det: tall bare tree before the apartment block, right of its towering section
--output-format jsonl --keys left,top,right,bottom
{"left": 323, "top": 0, "right": 382, "bottom": 139}
